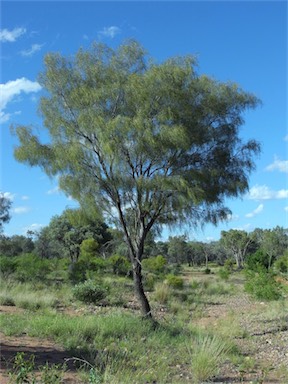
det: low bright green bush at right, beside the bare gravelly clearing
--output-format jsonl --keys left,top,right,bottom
{"left": 244, "top": 269, "right": 281, "bottom": 301}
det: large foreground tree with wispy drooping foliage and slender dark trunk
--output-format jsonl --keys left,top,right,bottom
{"left": 15, "top": 41, "right": 259, "bottom": 318}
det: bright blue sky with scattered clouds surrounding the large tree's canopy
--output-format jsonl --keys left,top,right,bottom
{"left": 0, "top": 0, "right": 288, "bottom": 240}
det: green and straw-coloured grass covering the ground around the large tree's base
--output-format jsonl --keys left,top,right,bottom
{"left": 0, "top": 273, "right": 287, "bottom": 384}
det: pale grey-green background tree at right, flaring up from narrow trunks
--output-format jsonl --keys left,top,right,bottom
{"left": 220, "top": 229, "right": 253, "bottom": 268}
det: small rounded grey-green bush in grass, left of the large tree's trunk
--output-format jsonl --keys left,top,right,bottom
{"left": 72, "top": 280, "right": 109, "bottom": 304}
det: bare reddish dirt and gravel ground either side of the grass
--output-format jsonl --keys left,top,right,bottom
{"left": 0, "top": 286, "right": 288, "bottom": 384}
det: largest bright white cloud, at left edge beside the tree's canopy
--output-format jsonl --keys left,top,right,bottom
{"left": 0, "top": 77, "right": 41, "bottom": 123}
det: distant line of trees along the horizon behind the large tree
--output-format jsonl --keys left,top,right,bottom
{"left": 0, "top": 209, "right": 288, "bottom": 269}
